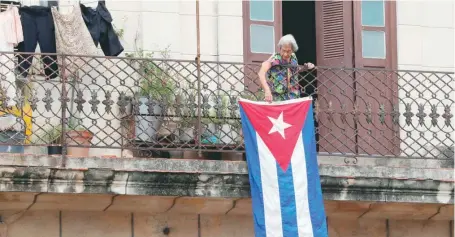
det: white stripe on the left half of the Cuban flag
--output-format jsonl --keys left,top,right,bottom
{"left": 256, "top": 132, "right": 283, "bottom": 237}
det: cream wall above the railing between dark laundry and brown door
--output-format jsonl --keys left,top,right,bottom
{"left": 105, "top": 0, "right": 243, "bottom": 62}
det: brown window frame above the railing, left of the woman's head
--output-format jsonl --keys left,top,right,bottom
{"left": 242, "top": 0, "right": 283, "bottom": 63}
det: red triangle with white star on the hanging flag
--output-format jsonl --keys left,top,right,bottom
{"left": 239, "top": 100, "right": 312, "bottom": 171}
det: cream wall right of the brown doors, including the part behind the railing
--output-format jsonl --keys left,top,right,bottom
{"left": 397, "top": 1, "right": 455, "bottom": 156}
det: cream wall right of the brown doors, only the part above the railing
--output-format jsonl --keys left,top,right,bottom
{"left": 397, "top": 1, "right": 455, "bottom": 71}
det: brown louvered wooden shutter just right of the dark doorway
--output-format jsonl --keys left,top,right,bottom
{"left": 316, "top": 1, "right": 356, "bottom": 153}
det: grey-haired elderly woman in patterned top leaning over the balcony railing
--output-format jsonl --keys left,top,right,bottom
{"left": 258, "top": 35, "right": 314, "bottom": 102}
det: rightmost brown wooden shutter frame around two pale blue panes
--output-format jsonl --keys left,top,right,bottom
{"left": 353, "top": 1, "right": 399, "bottom": 155}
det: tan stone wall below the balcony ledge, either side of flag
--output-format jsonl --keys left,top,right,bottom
{"left": 0, "top": 192, "right": 454, "bottom": 237}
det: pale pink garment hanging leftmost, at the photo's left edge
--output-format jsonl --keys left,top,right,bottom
{"left": 0, "top": 6, "right": 24, "bottom": 107}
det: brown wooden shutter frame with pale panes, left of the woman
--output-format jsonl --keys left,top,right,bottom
{"left": 243, "top": 0, "right": 282, "bottom": 93}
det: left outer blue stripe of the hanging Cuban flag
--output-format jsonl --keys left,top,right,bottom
{"left": 240, "top": 106, "right": 266, "bottom": 237}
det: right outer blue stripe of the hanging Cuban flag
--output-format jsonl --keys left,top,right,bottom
{"left": 302, "top": 106, "right": 328, "bottom": 237}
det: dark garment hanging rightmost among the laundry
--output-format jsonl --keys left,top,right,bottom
{"left": 80, "top": 1, "right": 124, "bottom": 56}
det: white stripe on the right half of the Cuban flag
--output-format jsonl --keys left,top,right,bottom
{"left": 291, "top": 133, "right": 313, "bottom": 237}
